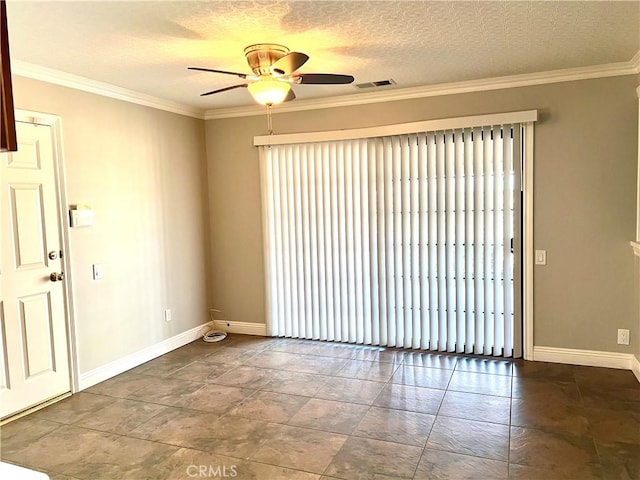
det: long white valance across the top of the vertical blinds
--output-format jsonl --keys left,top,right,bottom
{"left": 253, "top": 110, "right": 538, "bottom": 146}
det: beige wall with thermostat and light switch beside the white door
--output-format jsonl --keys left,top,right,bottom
{"left": 14, "top": 77, "right": 208, "bottom": 374}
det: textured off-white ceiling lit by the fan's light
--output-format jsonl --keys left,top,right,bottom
{"left": 7, "top": 0, "right": 640, "bottom": 110}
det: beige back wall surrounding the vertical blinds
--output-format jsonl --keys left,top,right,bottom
{"left": 206, "top": 75, "right": 639, "bottom": 353}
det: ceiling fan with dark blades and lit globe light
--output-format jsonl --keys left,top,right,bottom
{"left": 188, "top": 43, "right": 354, "bottom": 106}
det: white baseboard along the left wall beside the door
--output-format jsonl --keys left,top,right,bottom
{"left": 79, "top": 323, "right": 209, "bottom": 390}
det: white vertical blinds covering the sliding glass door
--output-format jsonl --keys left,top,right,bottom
{"left": 260, "top": 124, "right": 521, "bottom": 356}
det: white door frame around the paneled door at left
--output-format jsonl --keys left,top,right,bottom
{"left": 15, "top": 109, "right": 79, "bottom": 393}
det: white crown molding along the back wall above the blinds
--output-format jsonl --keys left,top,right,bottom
{"left": 204, "top": 51, "right": 640, "bottom": 120}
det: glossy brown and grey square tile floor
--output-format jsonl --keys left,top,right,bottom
{"left": 0, "top": 335, "right": 640, "bottom": 480}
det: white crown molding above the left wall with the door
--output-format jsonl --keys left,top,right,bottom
{"left": 11, "top": 60, "right": 204, "bottom": 119}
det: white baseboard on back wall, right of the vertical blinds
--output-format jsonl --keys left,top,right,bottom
{"left": 533, "top": 346, "right": 638, "bottom": 376}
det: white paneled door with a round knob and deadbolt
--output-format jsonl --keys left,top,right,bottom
{"left": 0, "top": 118, "right": 70, "bottom": 418}
